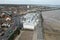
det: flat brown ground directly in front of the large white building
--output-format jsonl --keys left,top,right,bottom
{"left": 15, "top": 30, "right": 34, "bottom": 40}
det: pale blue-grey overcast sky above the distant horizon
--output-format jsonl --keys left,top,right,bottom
{"left": 0, "top": 0, "right": 60, "bottom": 5}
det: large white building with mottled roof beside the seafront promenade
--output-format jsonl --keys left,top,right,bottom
{"left": 23, "top": 13, "right": 39, "bottom": 30}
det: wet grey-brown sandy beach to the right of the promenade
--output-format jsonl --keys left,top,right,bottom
{"left": 43, "top": 10, "right": 60, "bottom": 40}
